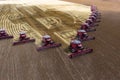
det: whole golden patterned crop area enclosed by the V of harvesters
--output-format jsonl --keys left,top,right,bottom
{"left": 0, "top": 4, "right": 90, "bottom": 45}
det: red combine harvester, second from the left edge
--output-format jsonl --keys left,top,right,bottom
{"left": 13, "top": 32, "right": 35, "bottom": 45}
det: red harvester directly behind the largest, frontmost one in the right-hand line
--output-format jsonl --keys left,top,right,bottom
{"left": 76, "top": 30, "right": 95, "bottom": 42}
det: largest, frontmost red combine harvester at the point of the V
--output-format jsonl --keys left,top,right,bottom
{"left": 68, "top": 40, "right": 93, "bottom": 58}
